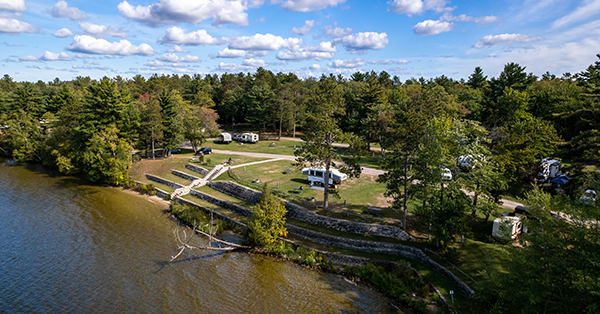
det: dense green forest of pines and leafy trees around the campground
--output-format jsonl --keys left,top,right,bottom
{"left": 0, "top": 55, "right": 600, "bottom": 312}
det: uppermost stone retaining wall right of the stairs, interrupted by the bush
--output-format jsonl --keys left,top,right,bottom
{"left": 207, "top": 181, "right": 412, "bottom": 240}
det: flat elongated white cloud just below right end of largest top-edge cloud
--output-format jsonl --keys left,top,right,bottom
{"left": 229, "top": 34, "right": 302, "bottom": 51}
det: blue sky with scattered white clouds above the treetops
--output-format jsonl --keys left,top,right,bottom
{"left": 0, "top": 0, "right": 600, "bottom": 82}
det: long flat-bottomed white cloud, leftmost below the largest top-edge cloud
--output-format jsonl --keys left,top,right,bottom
{"left": 67, "top": 35, "right": 155, "bottom": 56}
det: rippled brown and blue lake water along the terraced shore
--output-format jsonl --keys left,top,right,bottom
{"left": 0, "top": 160, "right": 392, "bottom": 314}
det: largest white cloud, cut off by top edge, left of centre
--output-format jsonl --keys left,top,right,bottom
{"left": 117, "top": 0, "right": 263, "bottom": 27}
